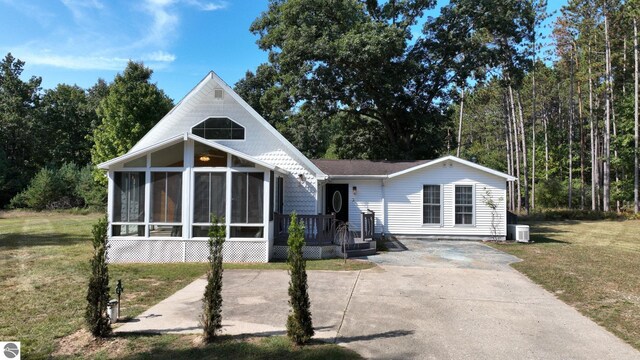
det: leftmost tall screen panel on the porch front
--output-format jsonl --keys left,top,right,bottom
{"left": 113, "top": 172, "right": 145, "bottom": 222}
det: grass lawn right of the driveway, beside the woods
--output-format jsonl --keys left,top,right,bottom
{"left": 493, "top": 220, "right": 640, "bottom": 350}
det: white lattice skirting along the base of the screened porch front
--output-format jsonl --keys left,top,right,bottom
{"left": 107, "top": 239, "right": 268, "bottom": 263}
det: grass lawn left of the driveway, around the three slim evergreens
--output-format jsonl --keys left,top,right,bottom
{"left": 0, "top": 211, "right": 373, "bottom": 359}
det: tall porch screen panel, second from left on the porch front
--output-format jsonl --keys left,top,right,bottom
{"left": 151, "top": 172, "right": 182, "bottom": 223}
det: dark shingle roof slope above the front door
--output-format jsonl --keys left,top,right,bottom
{"left": 311, "top": 159, "right": 430, "bottom": 176}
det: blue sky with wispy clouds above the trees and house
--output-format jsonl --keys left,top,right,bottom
{"left": 0, "top": 0, "right": 565, "bottom": 101}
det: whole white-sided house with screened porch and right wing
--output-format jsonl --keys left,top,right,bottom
{"left": 98, "top": 72, "right": 515, "bottom": 262}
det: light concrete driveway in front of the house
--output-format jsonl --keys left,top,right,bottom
{"left": 117, "top": 240, "right": 640, "bottom": 359}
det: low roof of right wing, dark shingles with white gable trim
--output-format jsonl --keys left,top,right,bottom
{"left": 312, "top": 155, "right": 516, "bottom": 181}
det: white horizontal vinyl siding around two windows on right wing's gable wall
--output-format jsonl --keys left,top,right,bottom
{"left": 384, "top": 162, "right": 506, "bottom": 237}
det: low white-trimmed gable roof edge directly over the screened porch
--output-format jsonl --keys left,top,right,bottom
{"left": 98, "top": 133, "right": 289, "bottom": 173}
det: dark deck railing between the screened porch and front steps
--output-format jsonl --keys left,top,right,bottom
{"left": 273, "top": 213, "right": 336, "bottom": 245}
